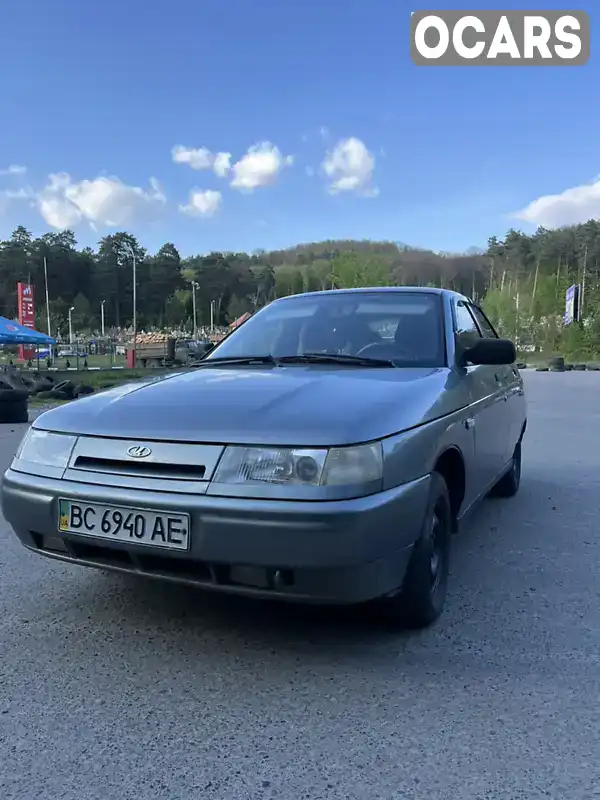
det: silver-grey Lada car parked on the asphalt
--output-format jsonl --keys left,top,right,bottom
{"left": 2, "top": 287, "right": 527, "bottom": 627}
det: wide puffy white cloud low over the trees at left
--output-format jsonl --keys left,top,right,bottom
{"left": 35, "top": 172, "right": 166, "bottom": 229}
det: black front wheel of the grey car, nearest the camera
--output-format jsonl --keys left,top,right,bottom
{"left": 377, "top": 472, "right": 452, "bottom": 630}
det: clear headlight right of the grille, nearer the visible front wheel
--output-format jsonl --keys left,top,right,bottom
{"left": 213, "top": 443, "right": 383, "bottom": 486}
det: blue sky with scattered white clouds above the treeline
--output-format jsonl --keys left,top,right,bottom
{"left": 0, "top": 0, "right": 600, "bottom": 255}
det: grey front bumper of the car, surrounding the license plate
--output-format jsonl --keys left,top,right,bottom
{"left": 1, "top": 469, "right": 429, "bottom": 603}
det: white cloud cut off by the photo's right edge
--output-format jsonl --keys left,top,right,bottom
{"left": 511, "top": 177, "right": 600, "bottom": 228}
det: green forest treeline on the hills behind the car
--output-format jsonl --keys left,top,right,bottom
{"left": 0, "top": 220, "right": 600, "bottom": 357}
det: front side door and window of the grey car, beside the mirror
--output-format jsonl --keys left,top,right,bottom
{"left": 454, "top": 300, "right": 509, "bottom": 495}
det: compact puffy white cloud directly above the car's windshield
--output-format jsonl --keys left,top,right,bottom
{"left": 321, "top": 137, "right": 379, "bottom": 197}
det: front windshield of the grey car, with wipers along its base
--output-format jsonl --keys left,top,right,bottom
{"left": 206, "top": 291, "right": 445, "bottom": 367}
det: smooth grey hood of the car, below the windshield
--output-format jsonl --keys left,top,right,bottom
{"left": 35, "top": 366, "right": 464, "bottom": 446}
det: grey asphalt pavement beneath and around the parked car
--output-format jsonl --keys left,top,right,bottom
{"left": 0, "top": 372, "right": 600, "bottom": 800}
